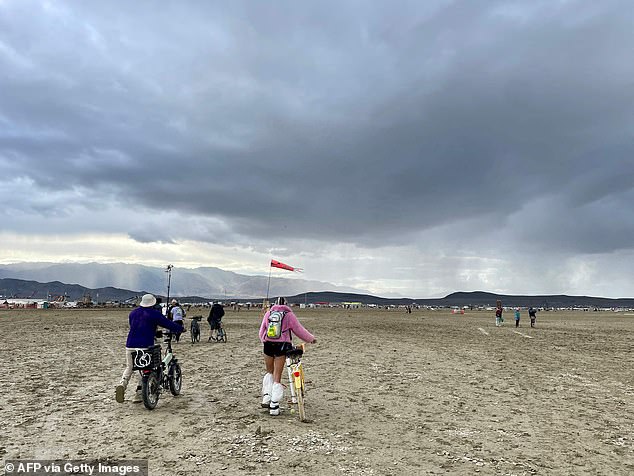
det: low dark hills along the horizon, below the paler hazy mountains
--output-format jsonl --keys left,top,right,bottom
{"left": 0, "top": 278, "right": 634, "bottom": 308}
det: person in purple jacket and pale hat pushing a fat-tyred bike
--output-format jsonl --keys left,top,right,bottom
{"left": 115, "top": 294, "right": 183, "bottom": 403}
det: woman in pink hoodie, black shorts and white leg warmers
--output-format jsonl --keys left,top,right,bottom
{"left": 260, "top": 297, "right": 317, "bottom": 415}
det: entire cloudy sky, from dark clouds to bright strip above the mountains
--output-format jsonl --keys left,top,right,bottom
{"left": 0, "top": 0, "right": 634, "bottom": 298}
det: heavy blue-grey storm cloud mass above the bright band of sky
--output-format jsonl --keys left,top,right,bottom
{"left": 0, "top": 1, "right": 634, "bottom": 252}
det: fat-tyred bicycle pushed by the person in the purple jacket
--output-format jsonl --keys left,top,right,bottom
{"left": 133, "top": 331, "right": 183, "bottom": 410}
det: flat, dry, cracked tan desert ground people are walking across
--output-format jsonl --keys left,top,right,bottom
{"left": 0, "top": 309, "right": 634, "bottom": 475}
